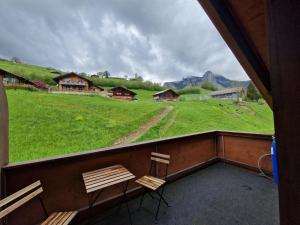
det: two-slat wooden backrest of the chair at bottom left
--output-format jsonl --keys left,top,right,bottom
{"left": 0, "top": 181, "right": 43, "bottom": 219}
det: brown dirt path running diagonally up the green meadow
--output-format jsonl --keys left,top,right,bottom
{"left": 113, "top": 106, "right": 174, "bottom": 145}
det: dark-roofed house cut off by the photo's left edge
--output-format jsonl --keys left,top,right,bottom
{"left": 0, "top": 69, "right": 34, "bottom": 87}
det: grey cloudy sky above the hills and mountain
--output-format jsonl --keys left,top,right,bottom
{"left": 0, "top": 0, "right": 248, "bottom": 82}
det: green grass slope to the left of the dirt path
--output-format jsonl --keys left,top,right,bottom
{"left": 7, "top": 90, "right": 163, "bottom": 162}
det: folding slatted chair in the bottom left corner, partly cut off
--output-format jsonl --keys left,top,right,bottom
{"left": 0, "top": 181, "right": 77, "bottom": 225}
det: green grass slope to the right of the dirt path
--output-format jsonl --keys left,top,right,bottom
{"left": 138, "top": 99, "right": 274, "bottom": 141}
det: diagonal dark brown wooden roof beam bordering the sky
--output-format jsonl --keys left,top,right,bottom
{"left": 198, "top": 0, "right": 272, "bottom": 108}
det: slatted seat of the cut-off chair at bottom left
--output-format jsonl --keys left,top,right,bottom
{"left": 41, "top": 211, "right": 78, "bottom": 225}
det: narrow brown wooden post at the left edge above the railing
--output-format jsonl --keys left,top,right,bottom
{"left": 0, "top": 76, "right": 8, "bottom": 193}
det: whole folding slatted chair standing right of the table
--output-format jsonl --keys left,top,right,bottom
{"left": 135, "top": 152, "right": 170, "bottom": 222}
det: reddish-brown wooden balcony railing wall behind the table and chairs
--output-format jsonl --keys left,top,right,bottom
{"left": 1, "top": 131, "right": 272, "bottom": 225}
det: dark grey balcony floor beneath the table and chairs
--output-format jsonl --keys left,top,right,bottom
{"left": 85, "top": 163, "right": 279, "bottom": 225}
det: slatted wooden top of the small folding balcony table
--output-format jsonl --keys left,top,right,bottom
{"left": 82, "top": 165, "right": 135, "bottom": 193}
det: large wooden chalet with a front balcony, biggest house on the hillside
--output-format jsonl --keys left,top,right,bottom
{"left": 53, "top": 72, "right": 104, "bottom": 93}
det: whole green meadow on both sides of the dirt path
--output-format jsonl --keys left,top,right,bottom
{"left": 7, "top": 90, "right": 274, "bottom": 162}
